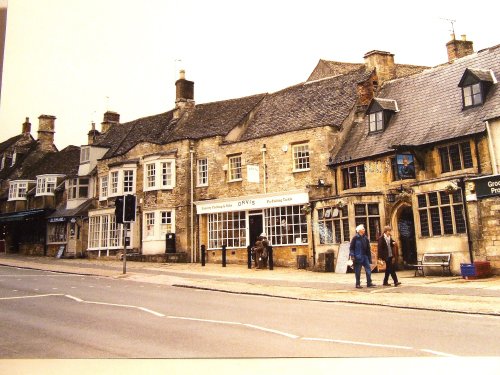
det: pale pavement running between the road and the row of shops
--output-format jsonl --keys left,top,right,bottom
{"left": 0, "top": 254, "right": 500, "bottom": 316}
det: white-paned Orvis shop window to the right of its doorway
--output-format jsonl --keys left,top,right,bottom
{"left": 265, "top": 206, "right": 308, "bottom": 246}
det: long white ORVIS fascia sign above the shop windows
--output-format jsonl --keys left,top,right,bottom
{"left": 195, "top": 192, "right": 309, "bottom": 215}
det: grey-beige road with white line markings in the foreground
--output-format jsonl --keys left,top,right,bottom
{"left": 0, "top": 267, "right": 500, "bottom": 359}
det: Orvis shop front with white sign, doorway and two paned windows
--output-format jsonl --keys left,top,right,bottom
{"left": 195, "top": 190, "right": 310, "bottom": 266}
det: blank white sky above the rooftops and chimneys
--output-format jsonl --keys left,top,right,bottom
{"left": 0, "top": 0, "right": 500, "bottom": 149}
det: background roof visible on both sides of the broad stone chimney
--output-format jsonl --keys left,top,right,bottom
{"left": 307, "top": 59, "right": 429, "bottom": 81}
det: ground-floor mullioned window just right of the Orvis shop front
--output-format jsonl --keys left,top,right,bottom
{"left": 318, "top": 206, "right": 349, "bottom": 244}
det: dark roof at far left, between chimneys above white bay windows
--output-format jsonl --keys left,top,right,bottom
{"left": 19, "top": 146, "right": 80, "bottom": 180}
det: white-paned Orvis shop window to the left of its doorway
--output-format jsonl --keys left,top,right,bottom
{"left": 208, "top": 211, "right": 247, "bottom": 249}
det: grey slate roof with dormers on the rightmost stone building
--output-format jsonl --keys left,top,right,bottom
{"left": 332, "top": 45, "right": 500, "bottom": 163}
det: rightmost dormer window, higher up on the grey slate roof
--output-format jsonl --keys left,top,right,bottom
{"left": 458, "top": 69, "right": 497, "bottom": 109}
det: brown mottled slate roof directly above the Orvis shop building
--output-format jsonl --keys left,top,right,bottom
{"left": 236, "top": 66, "right": 371, "bottom": 141}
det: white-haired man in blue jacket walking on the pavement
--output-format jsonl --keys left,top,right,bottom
{"left": 349, "top": 224, "right": 375, "bottom": 289}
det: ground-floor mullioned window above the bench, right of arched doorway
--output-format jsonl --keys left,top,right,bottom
{"left": 417, "top": 189, "right": 467, "bottom": 237}
